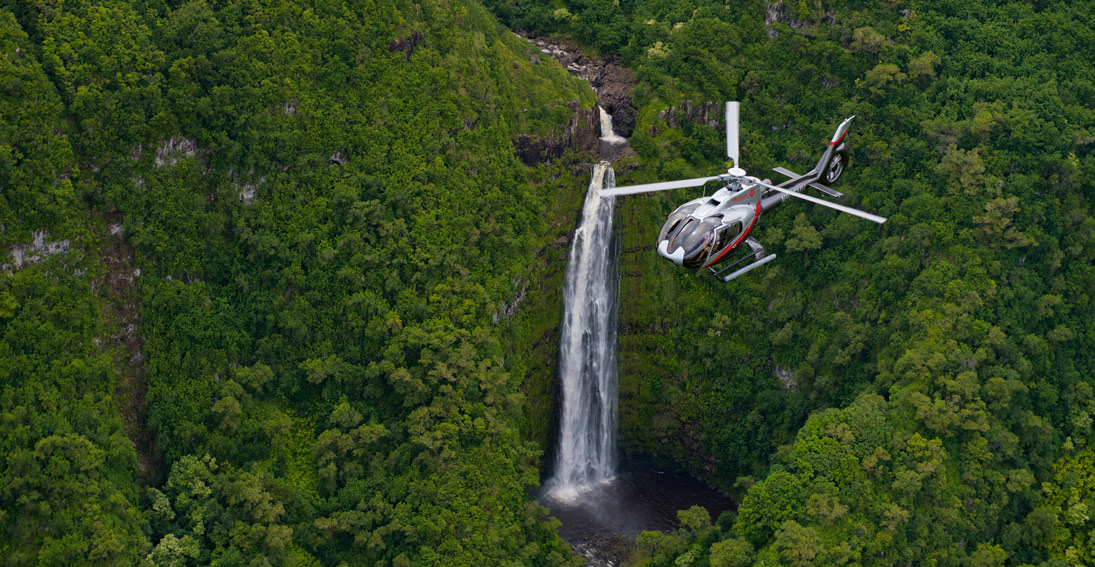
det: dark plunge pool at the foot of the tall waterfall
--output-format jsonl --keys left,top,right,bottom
{"left": 540, "top": 468, "right": 734, "bottom": 566}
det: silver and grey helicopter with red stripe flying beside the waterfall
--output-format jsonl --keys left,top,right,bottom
{"left": 600, "top": 101, "right": 886, "bottom": 281}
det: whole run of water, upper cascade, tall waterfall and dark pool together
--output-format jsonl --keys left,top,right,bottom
{"left": 541, "top": 45, "right": 734, "bottom": 567}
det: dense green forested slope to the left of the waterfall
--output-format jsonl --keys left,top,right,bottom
{"left": 0, "top": 0, "right": 592, "bottom": 566}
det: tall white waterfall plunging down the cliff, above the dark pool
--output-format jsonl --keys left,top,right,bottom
{"left": 546, "top": 160, "right": 618, "bottom": 500}
